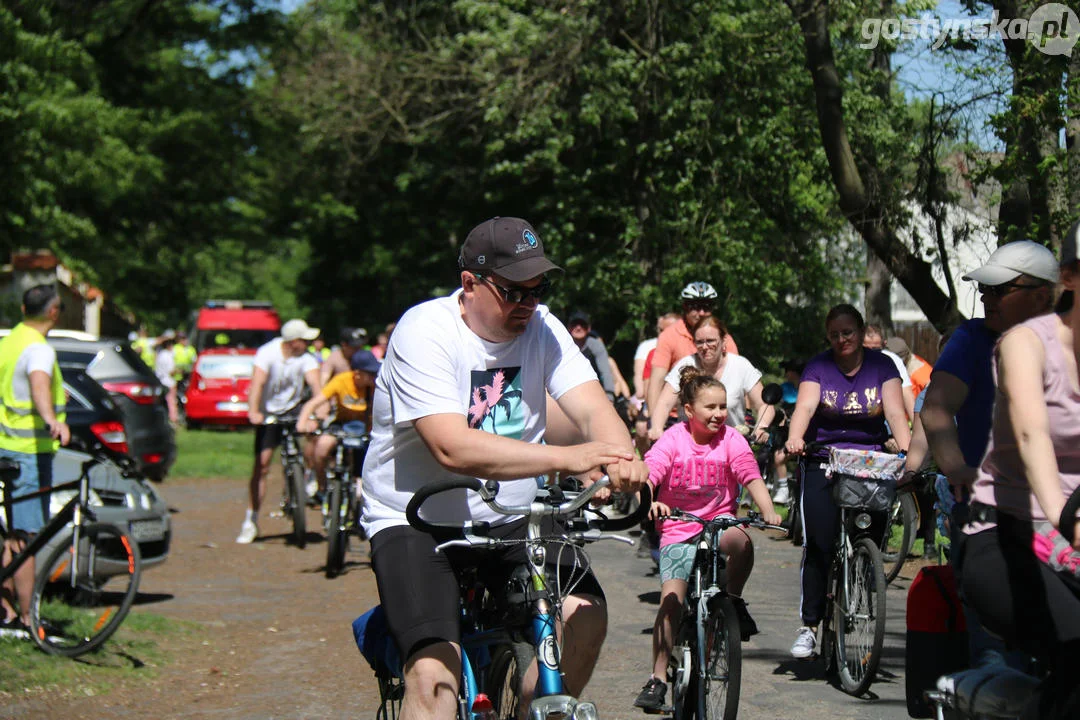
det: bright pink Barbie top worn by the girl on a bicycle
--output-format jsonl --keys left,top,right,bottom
{"left": 645, "top": 422, "right": 761, "bottom": 547}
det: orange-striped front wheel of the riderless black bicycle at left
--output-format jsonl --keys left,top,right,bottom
{"left": 30, "top": 522, "right": 143, "bottom": 657}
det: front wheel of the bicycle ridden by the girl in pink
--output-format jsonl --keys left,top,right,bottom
{"left": 698, "top": 596, "right": 742, "bottom": 720}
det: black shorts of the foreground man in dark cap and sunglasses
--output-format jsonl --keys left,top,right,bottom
{"left": 372, "top": 518, "right": 604, "bottom": 660}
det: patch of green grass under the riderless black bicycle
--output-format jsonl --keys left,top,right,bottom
{"left": 0, "top": 612, "right": 204, "bottom": 706}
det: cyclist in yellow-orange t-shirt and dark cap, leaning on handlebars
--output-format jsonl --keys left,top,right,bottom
{"left": 296, "top": 350, "right": 381, "bottom": 501}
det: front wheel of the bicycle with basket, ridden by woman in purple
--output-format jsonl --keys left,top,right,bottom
{"left": 834, "top": 538, "right": 886, "bottom": 695}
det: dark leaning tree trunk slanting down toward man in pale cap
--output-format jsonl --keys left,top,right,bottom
{"left": 788, "top": 0, "right": 963, "bottom": 331}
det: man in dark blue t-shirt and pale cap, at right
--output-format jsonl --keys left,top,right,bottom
{"left": 920, "top": 240, "right": 1058, "bottom": 665}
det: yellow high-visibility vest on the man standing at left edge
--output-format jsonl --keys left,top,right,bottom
{"left": 0, "top": 323, "right": 67, "bottom": 454}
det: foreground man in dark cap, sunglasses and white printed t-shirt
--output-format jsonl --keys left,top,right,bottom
{"left": 361, "top": 218, "right": 648, "bottom": 720}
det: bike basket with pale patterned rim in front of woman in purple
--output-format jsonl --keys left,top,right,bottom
{"left": 825, "top": 448, "right": 904, "bottom": 512}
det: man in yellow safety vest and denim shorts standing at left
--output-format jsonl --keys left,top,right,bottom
{"left": 0, "top": 285, "right": 70, "bottom": 629}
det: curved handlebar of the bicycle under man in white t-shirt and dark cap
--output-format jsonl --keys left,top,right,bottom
{"left": 405, "top": 475, "right": 651, "bottom": 533}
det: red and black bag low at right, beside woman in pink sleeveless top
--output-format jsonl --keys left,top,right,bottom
{"left": 904, "top": 566, "right": 969, "bottom": 718}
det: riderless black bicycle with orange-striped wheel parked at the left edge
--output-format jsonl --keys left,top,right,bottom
{"left": 0, "top": 446, "right": 143, "bottom": 657}
